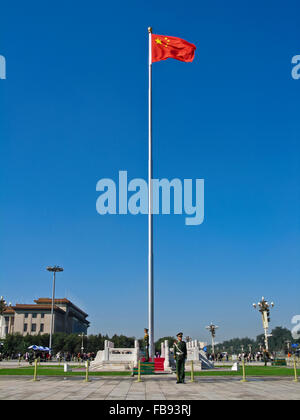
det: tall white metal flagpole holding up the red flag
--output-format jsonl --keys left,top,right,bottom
{"left": 148, "top": 27, "right": 154, "bottom": 358}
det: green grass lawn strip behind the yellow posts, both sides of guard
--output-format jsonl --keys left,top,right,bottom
{"left": 0, "top": 366, "right": 300, "bottom": 377}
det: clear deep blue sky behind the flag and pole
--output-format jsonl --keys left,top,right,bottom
{"left": 0, "top": 0, "right": 300, "bottom": 340}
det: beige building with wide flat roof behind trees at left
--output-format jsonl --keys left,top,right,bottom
{"left": 0, "top": 298, "right": 90, "bottom": 338}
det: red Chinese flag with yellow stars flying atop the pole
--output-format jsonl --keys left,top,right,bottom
{"left": 151, "top": 34, "right": 196, "bottom": 63}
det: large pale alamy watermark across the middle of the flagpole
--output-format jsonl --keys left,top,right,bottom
{"left": 96, "top": 171, "right": 204, "bottom": 226}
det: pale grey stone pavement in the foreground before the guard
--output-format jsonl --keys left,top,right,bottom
{"left": 0, "top": 375, "right": 300, "bottom": 401}
